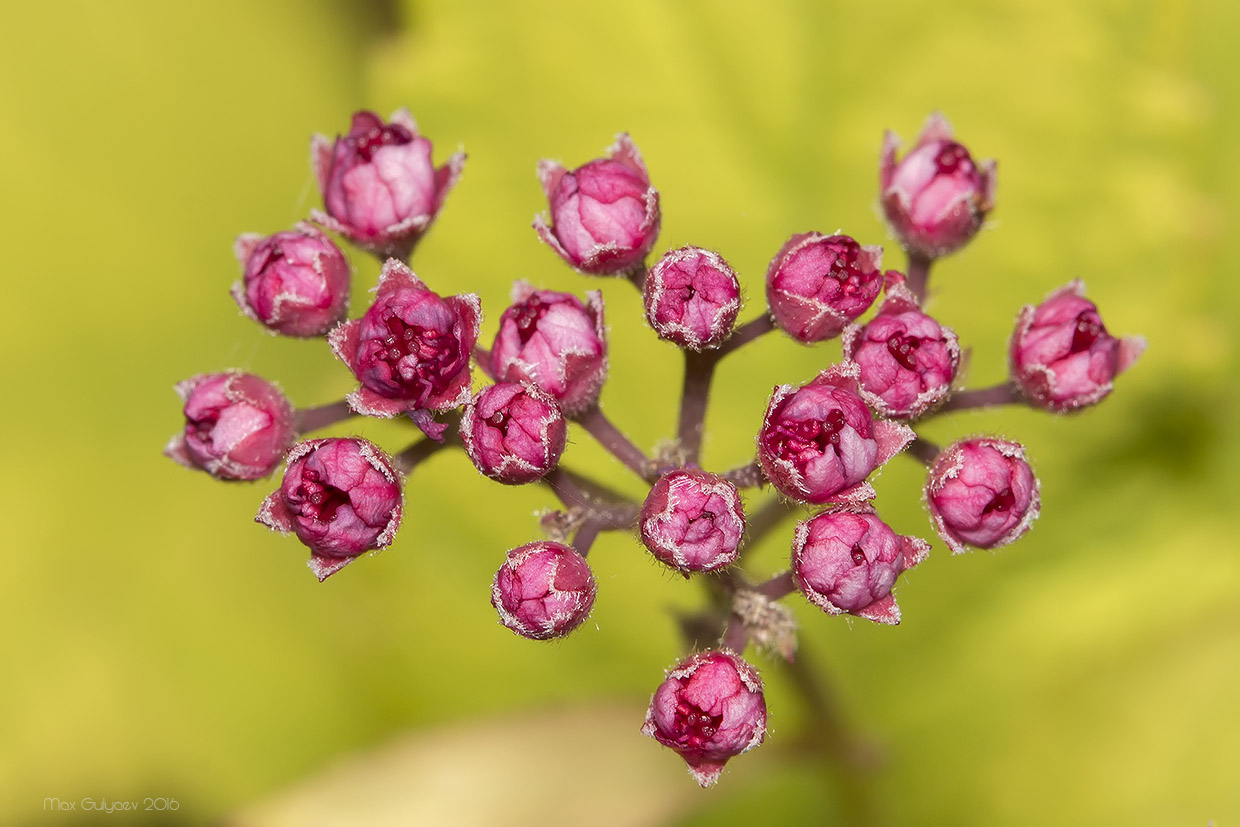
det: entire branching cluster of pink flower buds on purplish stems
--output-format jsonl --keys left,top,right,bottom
{"left": 165, "top": 110, "right": 1145, "bottom": 786}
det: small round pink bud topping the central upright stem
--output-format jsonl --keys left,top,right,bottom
{"left": 642, "top": 247, "right": 740, "bottom": 351}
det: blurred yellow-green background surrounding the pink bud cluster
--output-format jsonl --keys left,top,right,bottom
{"left": 0, "top": 0, "right": 1240, "bottom": 825}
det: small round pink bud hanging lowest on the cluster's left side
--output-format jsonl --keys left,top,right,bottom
{"left": 491, "top": 541, "right": 598, "bottom": 640}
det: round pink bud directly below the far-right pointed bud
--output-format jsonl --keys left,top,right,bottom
{"left": 925, "top": 436, "right": 1040, "bottom": 554}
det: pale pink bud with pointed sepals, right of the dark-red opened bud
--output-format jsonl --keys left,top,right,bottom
{"left": 491, "top": 281, "right": 608, "bottom": 417}
